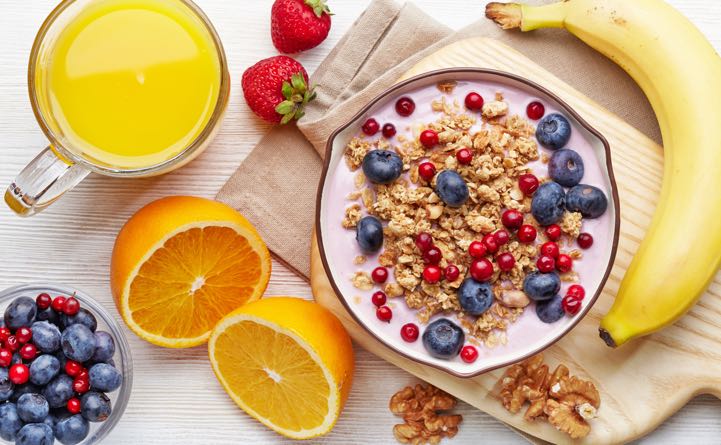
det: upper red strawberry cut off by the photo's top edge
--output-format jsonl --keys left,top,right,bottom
{"left": 270, "top": 0, "right": 331, "bottom": 53}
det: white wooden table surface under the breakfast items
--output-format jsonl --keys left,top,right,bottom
{"left": 0, "top": 0, "right": 721, "bottom": 445}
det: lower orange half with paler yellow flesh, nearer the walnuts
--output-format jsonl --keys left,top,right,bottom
{"left": 208, "top": 297, "right": 354, "bottom": 439}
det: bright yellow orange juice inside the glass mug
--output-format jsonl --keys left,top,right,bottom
{"left": 35, "top": 0, "right": 222, "bottom": 169}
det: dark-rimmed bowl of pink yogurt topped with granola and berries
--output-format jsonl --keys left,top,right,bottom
{"left": 316, "top": 68, "right": 620, "bottom": 377}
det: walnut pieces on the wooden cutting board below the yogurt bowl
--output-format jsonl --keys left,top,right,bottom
{"left": 499, "top": 354, "right": 601, "bottom": 439}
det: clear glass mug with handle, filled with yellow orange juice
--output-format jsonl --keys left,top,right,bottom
{"left": 5, "top": 0, "right": 230, "bottom": 216}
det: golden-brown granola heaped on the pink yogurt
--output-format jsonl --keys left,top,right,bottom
{"left": 342, "top": 83, "right": 581, "bottom": 347}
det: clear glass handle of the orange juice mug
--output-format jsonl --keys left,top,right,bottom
{"left": 5, "top": 147, "right": 90, "bottom": 216}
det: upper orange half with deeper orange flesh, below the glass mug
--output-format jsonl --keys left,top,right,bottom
{"left": 110, "top": 196, "right": 271, "bottom": 348}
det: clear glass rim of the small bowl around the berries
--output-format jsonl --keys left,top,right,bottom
{"left": 0, "top": 283, "right": 133, "bottom": 445}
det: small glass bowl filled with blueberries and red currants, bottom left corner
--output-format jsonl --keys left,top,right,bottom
{"left": 0, "top": 284, "right": 133, "bottom": 445}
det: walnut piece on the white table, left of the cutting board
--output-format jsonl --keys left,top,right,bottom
{"left": 389, "top": 385, "right": 463, "bottom": 445}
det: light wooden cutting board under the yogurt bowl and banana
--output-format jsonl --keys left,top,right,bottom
{"left": 311, "top": 38, "right": 721, "bottom": 444}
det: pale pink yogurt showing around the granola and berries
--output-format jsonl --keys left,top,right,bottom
{"left": 323, "top": 81, "right": 613, "bottom": 367}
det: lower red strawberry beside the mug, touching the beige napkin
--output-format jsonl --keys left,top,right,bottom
{"left": 242, "top": 56, "right": 315, "bottom": 124}
